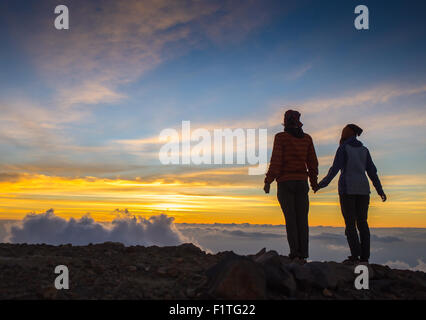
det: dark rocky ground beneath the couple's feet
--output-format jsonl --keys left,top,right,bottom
{"left": 0, "top": 243, "right": 426, "bottom": 299}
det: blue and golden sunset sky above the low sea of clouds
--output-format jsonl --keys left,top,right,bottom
{"left": 0, "top": 0, "right": 426, "bottom": 228}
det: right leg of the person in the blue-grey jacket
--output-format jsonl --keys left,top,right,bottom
{"left": 356, "top": 195, "right": 370, "bottom": 261}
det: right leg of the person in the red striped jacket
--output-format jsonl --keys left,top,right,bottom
{"left": 295, "top": 181, "right": 309, "bottom": 259}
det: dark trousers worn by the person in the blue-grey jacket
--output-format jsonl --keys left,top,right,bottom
{"left": 340, "top": 194, "right": 370, "bottom": 260}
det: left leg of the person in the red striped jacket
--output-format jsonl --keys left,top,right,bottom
{"left": 277, "top": 181, "right": 299, "bottom": 257}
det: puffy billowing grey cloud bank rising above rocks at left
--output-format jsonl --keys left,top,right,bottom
{"left": 5, "top": 209, "right": 191, "bottom": 246}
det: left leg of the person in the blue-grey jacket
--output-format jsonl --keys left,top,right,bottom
{"left": 339, "top": 194, "right": 361, "bottom": 257}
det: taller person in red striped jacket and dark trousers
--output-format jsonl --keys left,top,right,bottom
{"left": 264, "top": 110, "right": 318, "bottom": 263}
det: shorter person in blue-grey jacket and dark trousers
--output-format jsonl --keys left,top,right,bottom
{"left": 319, "top": 124, "right": 386, "bottom": 263}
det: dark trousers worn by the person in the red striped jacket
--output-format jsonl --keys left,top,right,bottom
{"left": 277, "top": 180, "right": 309, "bottom": 258}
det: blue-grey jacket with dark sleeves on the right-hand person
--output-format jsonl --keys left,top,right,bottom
{"left": 318, "top": 136, "right": 384, "bottom": 195}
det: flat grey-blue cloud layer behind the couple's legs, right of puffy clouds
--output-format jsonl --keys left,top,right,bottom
{"left": 177, "top": 224, "right": 426, "bottom": 271}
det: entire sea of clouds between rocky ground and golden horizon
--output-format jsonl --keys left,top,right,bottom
{"left": 0, "top": 209, "right": 426, "bottom": 272}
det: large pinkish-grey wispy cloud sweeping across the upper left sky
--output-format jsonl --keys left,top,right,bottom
{"left": 0, "top": 0, "right": 278, "bottom": 156}
